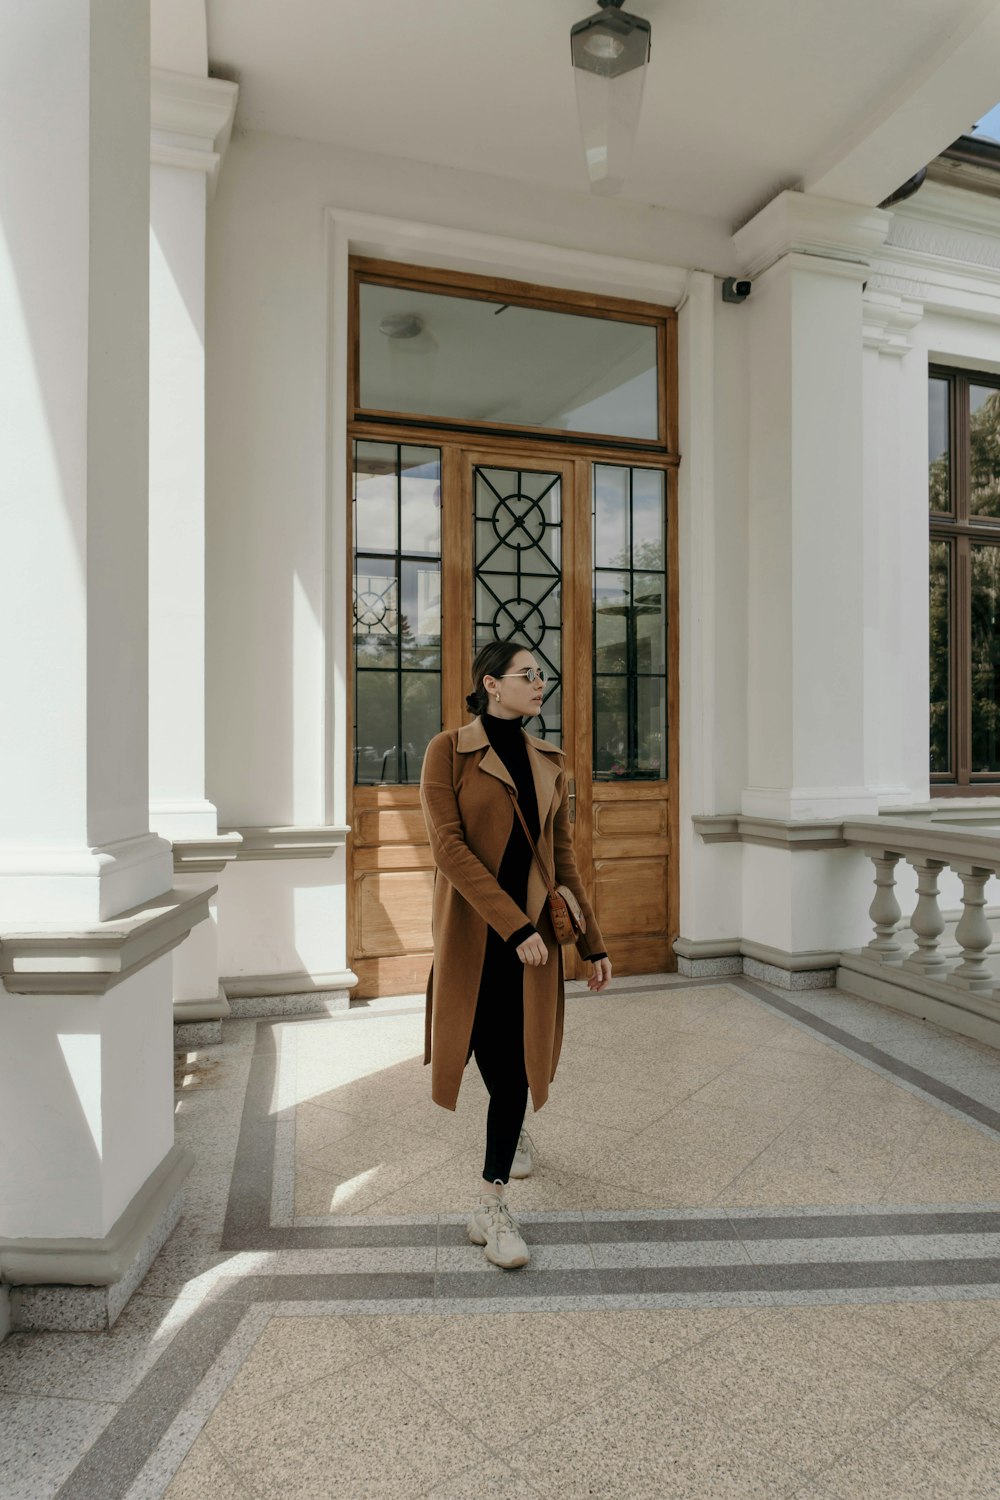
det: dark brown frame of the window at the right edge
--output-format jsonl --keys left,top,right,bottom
{"left": 927, "top": 363, "right": 1000, "bottom": 798}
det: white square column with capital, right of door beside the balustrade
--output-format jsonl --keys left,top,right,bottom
{"left": 735, "top": 192, "right": 889, "bottom": 819}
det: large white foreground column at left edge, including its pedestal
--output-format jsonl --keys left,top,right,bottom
{"left": 0, "top": 0, "right": 200, "bottom": 1320}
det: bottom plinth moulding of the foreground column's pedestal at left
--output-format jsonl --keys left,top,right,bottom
{"left": 0, "top": 1146, "right": 195, "bottom": 1334}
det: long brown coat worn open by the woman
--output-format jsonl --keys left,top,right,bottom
{"left": 420, "top": 719, "right": 604, "bottom": 1110}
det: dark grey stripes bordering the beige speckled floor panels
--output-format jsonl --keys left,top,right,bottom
{"left": 50, "top": 975, "right": 1000, "bottom": 1500}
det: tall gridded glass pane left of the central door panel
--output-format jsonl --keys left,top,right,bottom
{"left": 354, "top": 443, "right": 441, "bottom": 786}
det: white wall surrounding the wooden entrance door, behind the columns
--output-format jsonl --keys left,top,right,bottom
{"left": 207, "top": 134, "right": 745, "bottom": 975}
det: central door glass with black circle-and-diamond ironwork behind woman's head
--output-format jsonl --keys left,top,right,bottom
{"left": 472, "top": 464, "right": 562, "bottom": 744}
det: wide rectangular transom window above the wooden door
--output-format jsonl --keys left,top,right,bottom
{"left": 351, "top": 261, "right": 675, "bottom": 449}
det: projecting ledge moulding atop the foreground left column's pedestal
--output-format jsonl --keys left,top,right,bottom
{"left": 0, "top": 885, "right": 217, "bottom": 996}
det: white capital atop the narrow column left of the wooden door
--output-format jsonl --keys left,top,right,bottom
{"left": 150, "top": 68, "right": 238, "bottom": 198}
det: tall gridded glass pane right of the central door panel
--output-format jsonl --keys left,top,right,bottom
{"left": 594, "top": 464, "right": 667, "bottom": 782}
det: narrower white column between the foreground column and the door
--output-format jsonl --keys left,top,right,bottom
{"left": 150, "top": 68, "right": 237, "bottom": 1022}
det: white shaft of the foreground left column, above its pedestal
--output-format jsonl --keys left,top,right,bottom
{"left": 0, "top": 0, "right": 171, "bottom": 923}
